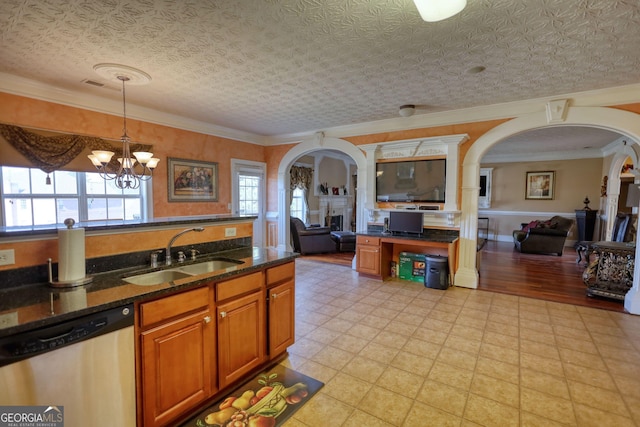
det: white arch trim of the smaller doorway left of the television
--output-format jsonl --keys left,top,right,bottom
{"left": 278, "top": 133, "right": 367, "bottom": 250}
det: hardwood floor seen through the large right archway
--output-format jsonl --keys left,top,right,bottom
{"left": 478, "top": 241, "right": 624, "bottom": 312}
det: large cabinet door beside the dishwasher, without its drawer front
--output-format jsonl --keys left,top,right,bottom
{"left": 141, "top": 309, "right": 215, "bottom": 426}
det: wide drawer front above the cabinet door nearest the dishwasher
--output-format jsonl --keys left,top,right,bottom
{"left": 140, "top": 286, "right": 209, "bottom": 327}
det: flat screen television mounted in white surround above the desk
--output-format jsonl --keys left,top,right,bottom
{"left": 376, "top": 159, "right": 447, "bottom": 203}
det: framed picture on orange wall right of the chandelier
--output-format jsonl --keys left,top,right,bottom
{"left": 167, "top": 158, "right": 218, "bottom": 202}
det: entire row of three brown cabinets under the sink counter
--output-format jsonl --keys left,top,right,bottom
{"left": 136, "top": 262, "right": 295, "bottom": 427}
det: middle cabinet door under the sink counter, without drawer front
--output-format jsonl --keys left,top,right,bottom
{"left": 217, "top": 291, "right": 266, "bottom": 388}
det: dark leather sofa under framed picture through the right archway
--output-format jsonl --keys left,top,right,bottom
{"left": 513, "top": 215, "right": 575, "bottom": 256}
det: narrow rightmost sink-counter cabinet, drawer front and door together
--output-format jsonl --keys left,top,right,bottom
{"left": 266, "top": 262, "right": 295, "bottom": 359}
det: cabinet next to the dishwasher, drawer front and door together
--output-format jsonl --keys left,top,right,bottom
{"left": 138, "top": 286, "right": 217, "bottom": 426}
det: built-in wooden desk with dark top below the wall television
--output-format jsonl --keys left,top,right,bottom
{"left": 356, "top": 233, "right": 458, "bottom": 280}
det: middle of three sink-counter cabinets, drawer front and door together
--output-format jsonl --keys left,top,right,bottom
{"left": 216, "top": 271, "right": 267, "bottom": 388}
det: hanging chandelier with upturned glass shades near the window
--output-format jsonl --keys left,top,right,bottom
{"left": 88, "top": 64, "right": 160, "bottom": 189}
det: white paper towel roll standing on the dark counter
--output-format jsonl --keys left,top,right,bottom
{"left": 58, "top": 228, "right": 86, "bottom": 282}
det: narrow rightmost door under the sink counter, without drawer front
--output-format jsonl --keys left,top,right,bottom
{"left": 267, "top": 280, "right": 295, "bottom": 358}
